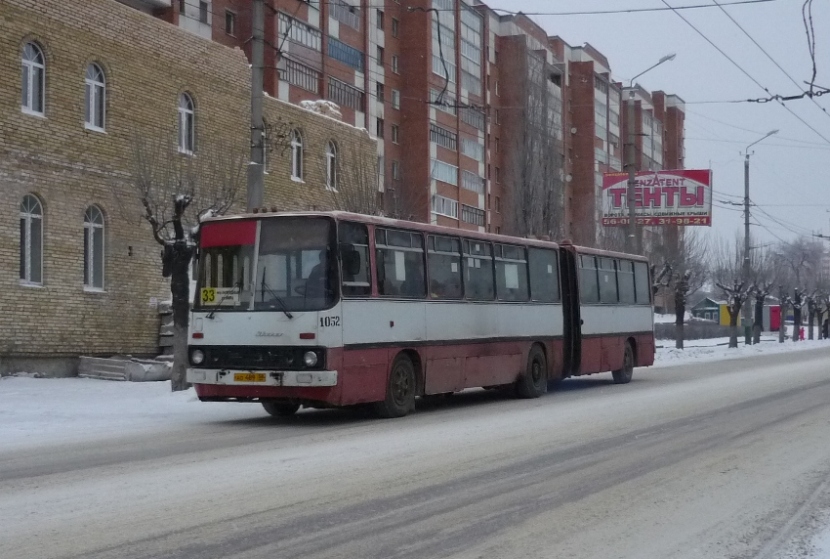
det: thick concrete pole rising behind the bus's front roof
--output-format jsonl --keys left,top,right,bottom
{"left": 248, "top": 0, "right": 265, "bottom": 211}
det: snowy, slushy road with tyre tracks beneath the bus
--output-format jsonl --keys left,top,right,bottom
{"left": 0, "top": 349, "right": 830, "bottom": 559}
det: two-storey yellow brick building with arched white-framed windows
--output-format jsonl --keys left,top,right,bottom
{"left": 0, "top": 0, "right": 376, "bottom": 375}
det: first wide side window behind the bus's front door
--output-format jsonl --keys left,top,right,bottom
{"left": 375, "top": 229, "right": 426, "bottom": 298}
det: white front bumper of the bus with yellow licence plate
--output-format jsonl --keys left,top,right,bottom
{"left": 187, "top": 368, "right": 337, "bottom": 388}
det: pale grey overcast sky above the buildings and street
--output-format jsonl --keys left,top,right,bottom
{"left": 485, "top": 0, "right": 830, "bottom": 246}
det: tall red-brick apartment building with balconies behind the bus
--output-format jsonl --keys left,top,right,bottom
{"left": 122, "top": 0, "right": 683, "bottom": 245}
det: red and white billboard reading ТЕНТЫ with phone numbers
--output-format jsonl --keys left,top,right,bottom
{"left": 602, "top": 169, "right": 712, "bottom": 227}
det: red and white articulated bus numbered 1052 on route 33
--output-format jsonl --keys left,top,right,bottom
{"left": 187, "top": 212, "right": 654, "bottom": 417}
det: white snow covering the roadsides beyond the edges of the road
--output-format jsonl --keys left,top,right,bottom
{"left": 0, "top": 335, "right": 830, "bottom": 559}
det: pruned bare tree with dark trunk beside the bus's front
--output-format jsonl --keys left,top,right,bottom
{"left": 116, "top": 134, "right": 248, "bottom": 391}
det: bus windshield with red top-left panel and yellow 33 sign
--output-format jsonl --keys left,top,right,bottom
{"left": 196, "top": 217, "right": 337, "bottom": 313}
